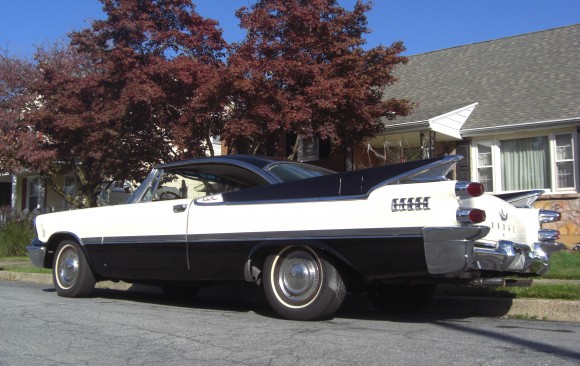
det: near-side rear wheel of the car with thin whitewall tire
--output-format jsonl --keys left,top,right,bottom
{"left": 264, "top": 247, "right": 346, "bottom": 320}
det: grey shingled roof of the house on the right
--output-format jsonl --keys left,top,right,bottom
{"left": 384, "top": 24, "right": 580, "bottom": 131}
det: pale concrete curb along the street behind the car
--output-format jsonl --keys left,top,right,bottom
{"left": 0, "top": 271, "right": 580, "bottom": 322}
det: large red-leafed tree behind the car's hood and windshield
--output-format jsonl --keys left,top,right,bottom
{"left": 1, "top": 0, "right": 227, "bottom": 207}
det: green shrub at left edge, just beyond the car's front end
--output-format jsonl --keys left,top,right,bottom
{"left": 0, "top": 209, "right": 34, "bottom": 257}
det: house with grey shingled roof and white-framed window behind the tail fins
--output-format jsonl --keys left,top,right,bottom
{"left": 356, "top": 24, "right": 580, "bottom": 244}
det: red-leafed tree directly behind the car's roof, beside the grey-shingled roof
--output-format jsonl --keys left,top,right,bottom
{"left": 222, "top": 0, "right": 411, "bottom": 165}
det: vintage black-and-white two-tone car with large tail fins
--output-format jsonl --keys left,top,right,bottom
{"left": 28, "top": 155, "right": 561, "bottom": 320}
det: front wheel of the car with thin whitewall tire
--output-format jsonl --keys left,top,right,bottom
{"left": 52, "top": 240, "right": 96, "bottom": 297}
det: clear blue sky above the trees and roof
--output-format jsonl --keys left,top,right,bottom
{"left": 0, "top": 0, "right": 580, "bottom": 57}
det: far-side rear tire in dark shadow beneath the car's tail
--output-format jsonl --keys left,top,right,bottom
{"left": 367, "top": 285, "right": 437, "bottom": 312}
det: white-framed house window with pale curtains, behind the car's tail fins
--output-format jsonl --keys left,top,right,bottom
{"left": 473, "top": 133, "right": 577, "bottom": 193}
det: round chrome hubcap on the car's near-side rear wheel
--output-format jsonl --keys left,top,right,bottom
{"left": 278, "top": 251, "right": 320, "bottom": 302}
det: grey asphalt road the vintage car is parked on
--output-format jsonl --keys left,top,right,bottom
{"left": 0, "top": 281, "right": 580, "bottom": 365}
